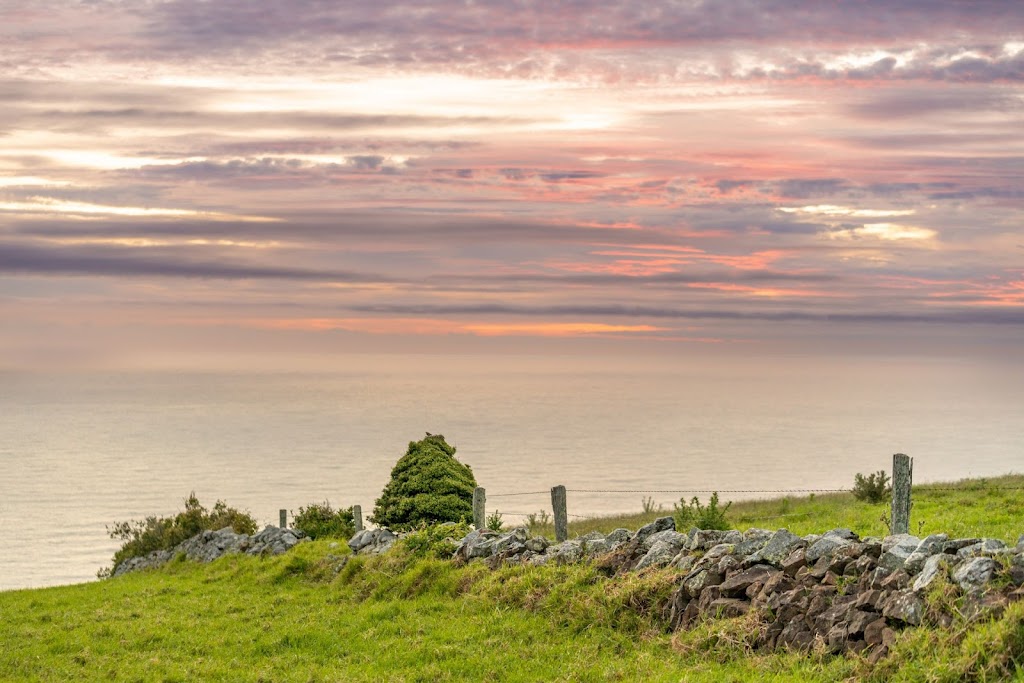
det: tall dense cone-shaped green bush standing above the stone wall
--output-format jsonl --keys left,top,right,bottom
{"left": 371, "top": 434, "right": 476, "bottom": 530}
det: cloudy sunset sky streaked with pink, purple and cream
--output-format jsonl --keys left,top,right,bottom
{"left": 0, "top": 0, "right": 1024, "bottom": 369}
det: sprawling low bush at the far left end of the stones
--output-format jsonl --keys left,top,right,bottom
{"left": 101, "top": 492, "right": 256, "bottom": 573}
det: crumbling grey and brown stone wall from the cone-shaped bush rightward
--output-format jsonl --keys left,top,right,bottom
{"left": 349, "top": 517, "right": 1024, "bottom": 659}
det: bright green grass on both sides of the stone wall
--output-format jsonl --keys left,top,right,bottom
{"left": 0, "top": 477, "right": 1024, "bottom": 683}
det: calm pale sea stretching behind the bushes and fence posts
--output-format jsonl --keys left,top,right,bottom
{"left": 0, "top": 359, "right": 1024, "bottom": 589}
